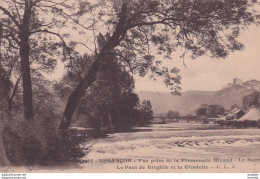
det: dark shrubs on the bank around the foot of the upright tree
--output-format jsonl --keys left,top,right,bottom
{"left": 1, "top": 99, "right": 86, "bottom": 166}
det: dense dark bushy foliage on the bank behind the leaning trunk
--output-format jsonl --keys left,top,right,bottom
{"left": 55, "top": 55, "right": 153, "bottom": 133}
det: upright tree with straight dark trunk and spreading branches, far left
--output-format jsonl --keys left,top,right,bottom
{"left": 0, "top": 0, "right": 88, "bottom": 120}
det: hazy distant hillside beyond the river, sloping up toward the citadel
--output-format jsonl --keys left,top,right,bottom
{"left": 137, "top": 85, "right": 255, "bottom": 115}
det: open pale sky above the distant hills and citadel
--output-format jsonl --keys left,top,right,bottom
{"left": 135, "top": 26, "right": 260, "bottom": 92}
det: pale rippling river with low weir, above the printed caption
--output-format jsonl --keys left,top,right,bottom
{"left": 81, "top": 121, "right": 260, "bottom": 172}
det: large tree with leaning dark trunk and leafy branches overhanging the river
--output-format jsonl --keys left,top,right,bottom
{"left": 60, "top": 0, "right": 258, "bottom": 129}
